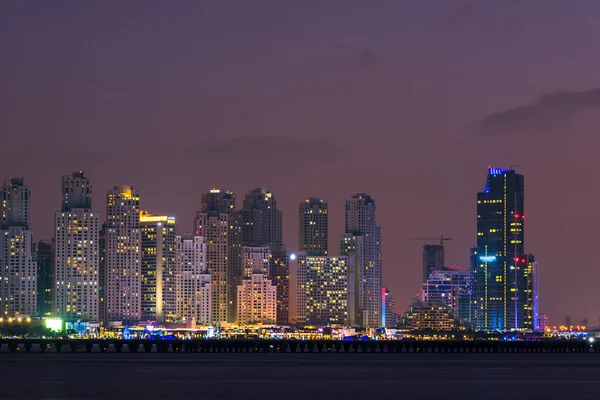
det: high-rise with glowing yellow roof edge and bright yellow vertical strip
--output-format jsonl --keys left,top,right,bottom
{"left": 140, "top": 211, "right": 177, "bottom": 322}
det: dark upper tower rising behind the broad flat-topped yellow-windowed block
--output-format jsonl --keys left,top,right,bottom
{"left": 298, "top": 197, "right": 329, "bottom": 256}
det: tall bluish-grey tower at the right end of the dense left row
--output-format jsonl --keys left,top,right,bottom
{"left": 341, "top": 193, "right": 382, "bottom": 327}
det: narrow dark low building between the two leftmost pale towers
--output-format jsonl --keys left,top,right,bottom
{"left": 36, "top": 240, "right": 56, "bottom": 317}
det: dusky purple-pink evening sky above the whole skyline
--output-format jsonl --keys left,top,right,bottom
{"left": 0, "top": 0, "right": 600, "bottom": 324}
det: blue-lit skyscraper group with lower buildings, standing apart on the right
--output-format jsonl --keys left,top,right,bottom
{"left": 404, "top": 167, "right": 546, "bottom": 331}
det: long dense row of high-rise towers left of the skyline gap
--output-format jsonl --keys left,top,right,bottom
{"left": 0, "top": 172, "right": 385, "bottom": 327}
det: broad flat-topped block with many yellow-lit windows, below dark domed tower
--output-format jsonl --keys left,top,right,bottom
{"left": 306, "top": 256, "right": 350, "bottom": 325}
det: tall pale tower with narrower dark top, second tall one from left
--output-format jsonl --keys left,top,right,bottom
{"left": 54, "top": 172, "right": 100, "bottom": 321}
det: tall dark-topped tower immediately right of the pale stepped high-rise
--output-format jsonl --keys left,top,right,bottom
{"left": 194, "top": 189, "right": 236, "bottom": 325}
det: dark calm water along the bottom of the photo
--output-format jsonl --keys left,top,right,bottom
{"left": 0, "top": 353, "right": 600, "bottom": 400}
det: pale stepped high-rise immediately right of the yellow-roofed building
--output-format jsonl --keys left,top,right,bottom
{"left": 175, "top": 235, "right": 212, "bottom": 325}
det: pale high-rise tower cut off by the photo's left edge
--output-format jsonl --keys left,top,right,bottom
{"left": 0, "top": 178, "right": 38, "bottom": 318}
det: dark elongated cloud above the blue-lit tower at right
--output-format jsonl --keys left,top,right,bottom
{"left": 474, "top": 88, "right": 600, "bottom": 133}
